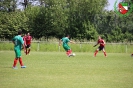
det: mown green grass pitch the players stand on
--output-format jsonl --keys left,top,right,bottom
{"left": 0, "top": 51, "right": 133, "bottom": 88}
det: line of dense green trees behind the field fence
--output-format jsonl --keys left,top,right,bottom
{"left": 0, "top": 0, "right": 133, "bottom": 42}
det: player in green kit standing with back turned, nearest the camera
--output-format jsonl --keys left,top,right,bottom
{"left": 12, "top": 30, "right": 26, "bottom": 69}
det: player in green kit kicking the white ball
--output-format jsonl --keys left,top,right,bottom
{"left": 59, "top": 35, "right": 75, "bottom": 57}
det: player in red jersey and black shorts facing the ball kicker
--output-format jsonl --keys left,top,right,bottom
{"left": 94, "top": 36, "right": 107, "bottom": 57}
